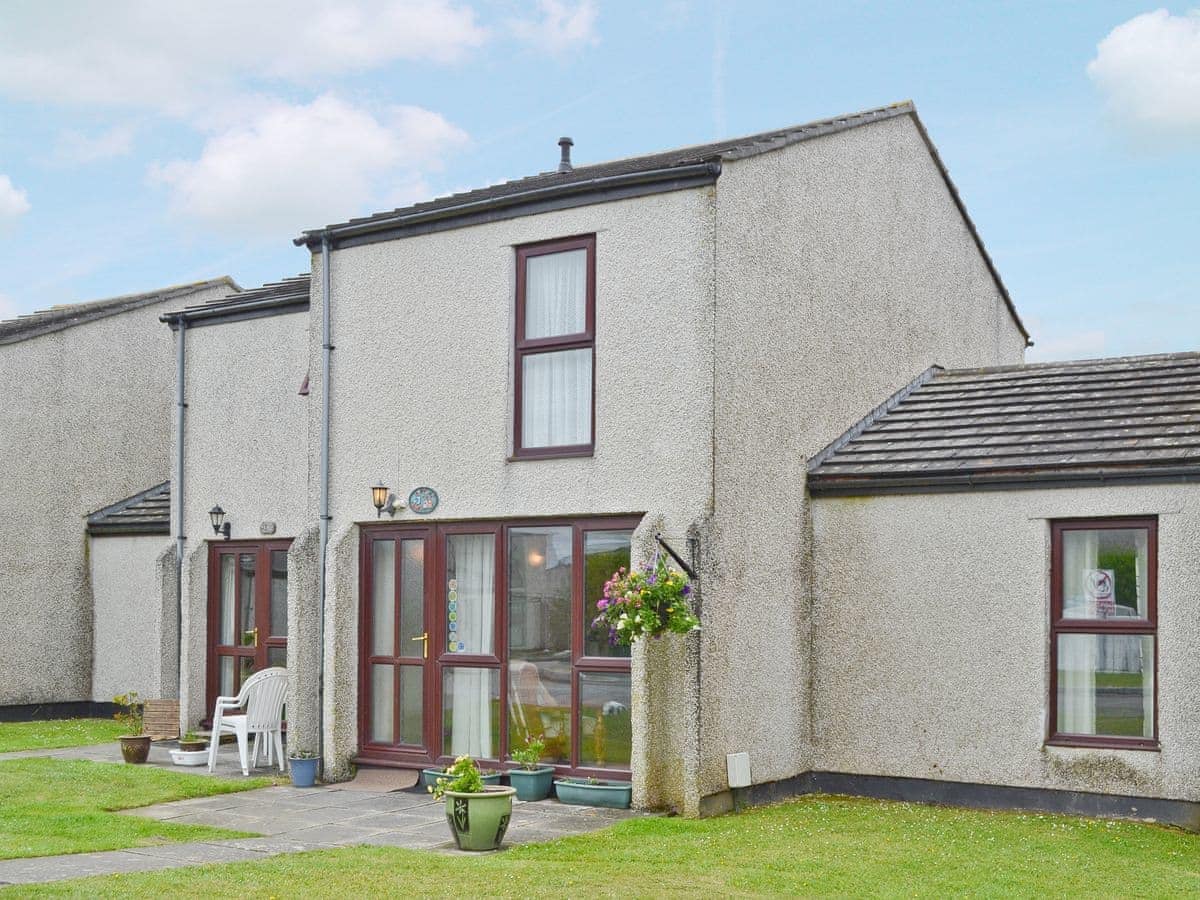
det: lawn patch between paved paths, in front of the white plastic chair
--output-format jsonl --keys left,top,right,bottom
{"left": 0, "top": 758, "right": 271, "bottom": 859}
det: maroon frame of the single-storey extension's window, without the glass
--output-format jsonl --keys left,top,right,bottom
{"left": 1046, "top": 516, "right": 1159, "bottom": 750}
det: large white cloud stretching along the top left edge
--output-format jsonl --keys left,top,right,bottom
{"left": 0, "top": 0, "right": 486, "bottom": 115}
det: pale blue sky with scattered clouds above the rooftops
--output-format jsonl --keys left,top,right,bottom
{"left": 0, "top": 0, "right": 1200, "bottom": 360}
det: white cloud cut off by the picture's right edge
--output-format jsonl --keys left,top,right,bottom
{"left": 1087, "top": 10, "right": 1200, "bottom": 134}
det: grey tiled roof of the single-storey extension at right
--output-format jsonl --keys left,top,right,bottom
{"left": 809, "top": 353, "right": 1200, "bottom": 494}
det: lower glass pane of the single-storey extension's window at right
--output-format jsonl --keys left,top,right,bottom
{"left": 1057, "top": 635, "right": 1154, "bottom": 738}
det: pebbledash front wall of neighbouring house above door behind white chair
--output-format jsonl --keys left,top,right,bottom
{"left": 175, "top": 307, "right": 308, "bottom": 727}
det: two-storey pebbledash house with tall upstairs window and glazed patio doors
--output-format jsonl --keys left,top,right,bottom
{"left": 253, "top": 103, "right": 1027, "bottom": 815}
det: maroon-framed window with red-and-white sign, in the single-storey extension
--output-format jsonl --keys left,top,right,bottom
{"left": 1049, "top": 518, "right": 1158, "bottom": 749}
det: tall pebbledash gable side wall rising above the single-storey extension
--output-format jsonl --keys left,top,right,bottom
{"left": 698, "top": 109, "right": 1026, "bottom": 811}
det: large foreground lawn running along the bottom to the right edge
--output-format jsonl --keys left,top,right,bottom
{"left": 16, "top": 797, "right": 1200, "bottom": 898}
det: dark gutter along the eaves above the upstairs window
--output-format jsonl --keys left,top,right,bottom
{"left": 292, "top": 160, "right": 721, "bottom": 252}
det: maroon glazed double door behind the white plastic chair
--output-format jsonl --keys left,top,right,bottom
{"left": 208, "top": 541, "right": 290, "bottom": 710}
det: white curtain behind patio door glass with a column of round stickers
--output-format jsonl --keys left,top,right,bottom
{"left": 443, "top": 534, "right": 497, "bottom": 757}
